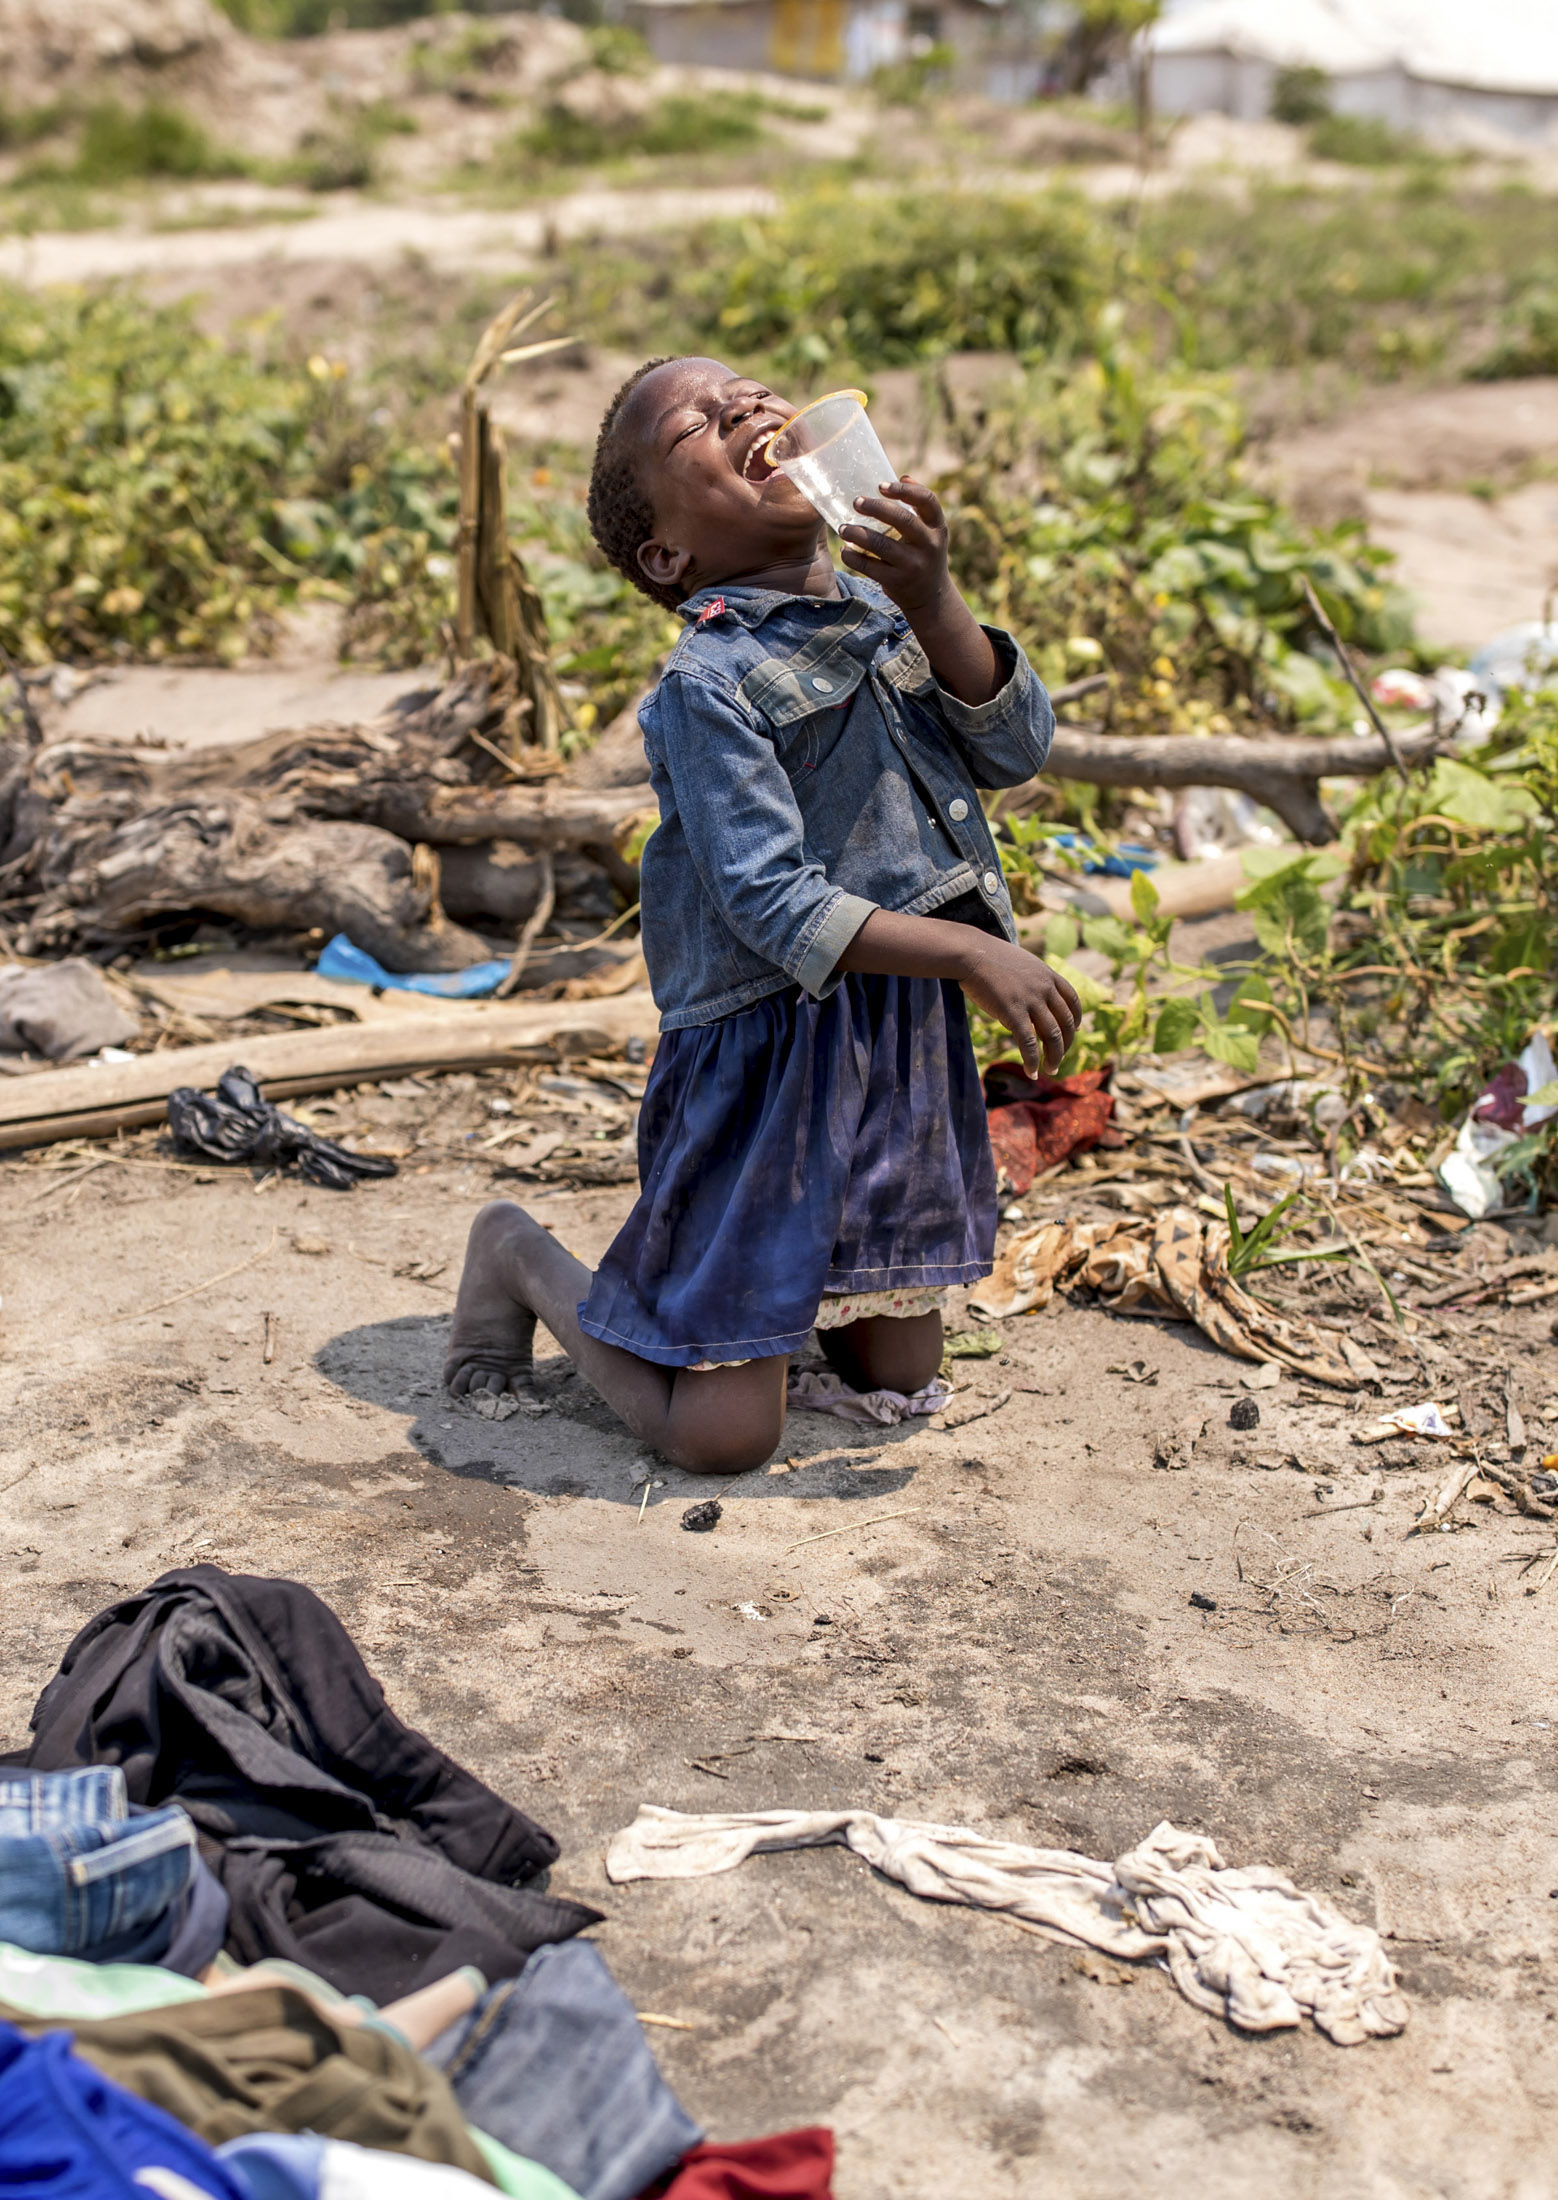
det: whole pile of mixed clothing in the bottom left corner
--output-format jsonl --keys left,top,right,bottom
{"left": 0, "top": 1566, "right": 832, "bottom": 2200}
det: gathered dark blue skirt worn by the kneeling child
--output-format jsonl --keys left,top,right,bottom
{"left": 579, "top": 972, "right": 997, "bottom": 1368}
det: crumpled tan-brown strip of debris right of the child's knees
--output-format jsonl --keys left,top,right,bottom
{"left": 968, "top": 1206, "right": 1380, "bottom": 1390}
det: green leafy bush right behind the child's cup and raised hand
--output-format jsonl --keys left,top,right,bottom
{"left": 940, "top": 343, "right": 1411, "bottom": 733}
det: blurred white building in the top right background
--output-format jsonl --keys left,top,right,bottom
{"left": 1146, "top": 0, "right": 1558, "bottom": 145}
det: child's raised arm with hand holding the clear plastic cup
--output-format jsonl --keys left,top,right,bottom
{"left": 841, "top": 482, "right": 1054, "bottom": 788}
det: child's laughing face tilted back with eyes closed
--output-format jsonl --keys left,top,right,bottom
{"left": 627, "top": 359, "right": 823, "bottom": 594}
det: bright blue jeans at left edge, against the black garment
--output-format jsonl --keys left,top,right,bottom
{"left": 0, "top": 1764, "right": 200, "bottom": 1962}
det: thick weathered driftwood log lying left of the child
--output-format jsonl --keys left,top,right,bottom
{"left": 0, "top": 660, "right": 651, "bottom": 970}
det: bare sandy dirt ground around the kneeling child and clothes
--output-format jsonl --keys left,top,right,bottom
{"left": 0, "top": 1071, "right": 1558, "bottom": 2200}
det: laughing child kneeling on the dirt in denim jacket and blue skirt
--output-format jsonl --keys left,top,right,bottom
{"left": 445, "top": 359, "right": 1078, "bottom": 1474}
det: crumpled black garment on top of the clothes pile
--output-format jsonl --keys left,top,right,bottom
{"left": 0, "top": 1566, "right": 601, "bottom": 2002}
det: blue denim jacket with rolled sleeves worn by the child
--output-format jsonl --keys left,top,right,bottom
{"left": 638, "top": 572, "right": 1054, "bottom": 1032}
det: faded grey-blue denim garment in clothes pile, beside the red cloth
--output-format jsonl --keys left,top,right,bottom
{"left": 427, "top": 1940, "right": 704, "bottom": 2200}
